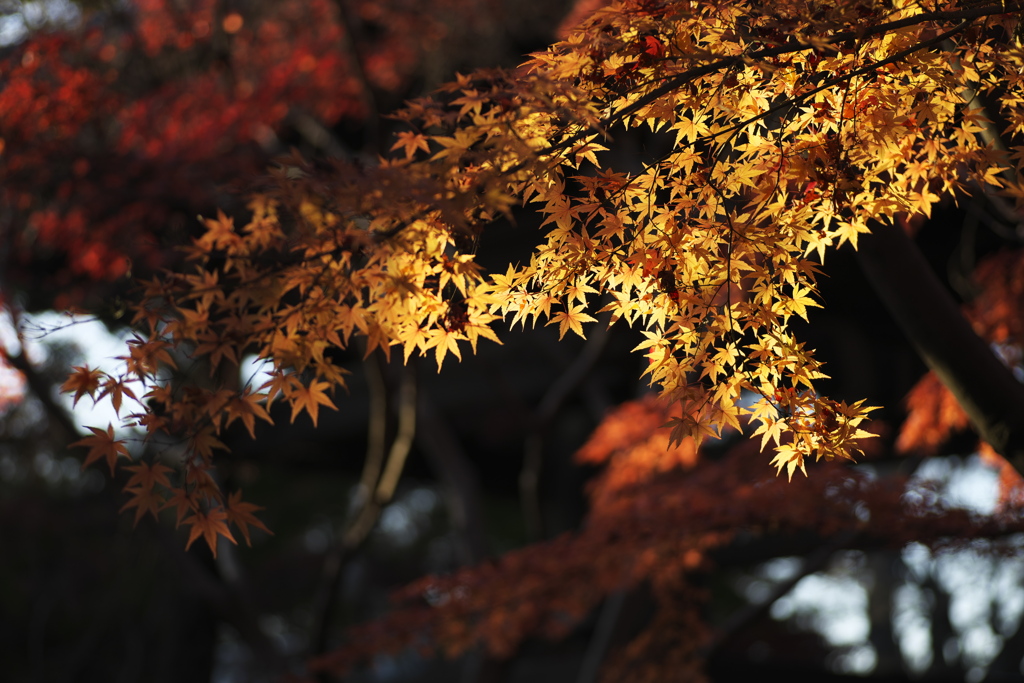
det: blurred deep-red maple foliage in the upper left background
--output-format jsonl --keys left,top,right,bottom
{"left": 0, "top": 0, "right": 495, "bottom": 307}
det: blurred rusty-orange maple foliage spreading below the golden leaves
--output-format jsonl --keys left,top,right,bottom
{"left": 312, "top": 396, "right": 1020, "bottom": 682}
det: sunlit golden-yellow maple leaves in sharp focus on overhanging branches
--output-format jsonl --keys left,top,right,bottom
{"left": 66, "top": 0, "right": 1024, "bottom": 547}
